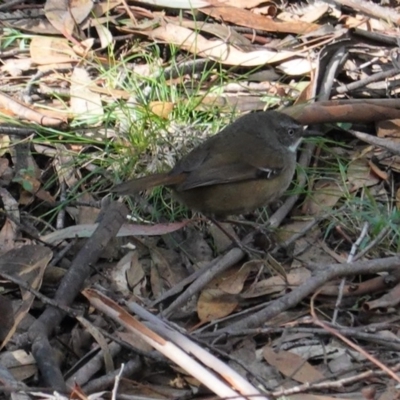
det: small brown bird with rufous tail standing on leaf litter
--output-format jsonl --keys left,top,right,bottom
{"left": 112, "top": 111, "right": 315, "bottom": 217}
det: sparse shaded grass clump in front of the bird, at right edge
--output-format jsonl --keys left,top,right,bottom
{"left": 300, "top": 138, "right": 400, "bottom": 256}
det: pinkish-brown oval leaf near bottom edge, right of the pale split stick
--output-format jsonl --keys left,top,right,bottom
{"left": 263, "top": 346, "right": 325, "bottom": 383}
